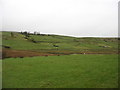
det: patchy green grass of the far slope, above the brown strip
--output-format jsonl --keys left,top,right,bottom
{"left": 2, "top": 32, "right": 118, "bottom": 52}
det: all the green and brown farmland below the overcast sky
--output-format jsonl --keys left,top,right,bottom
{"left": 0, "top": 32, "right": 119, "bottom": 88}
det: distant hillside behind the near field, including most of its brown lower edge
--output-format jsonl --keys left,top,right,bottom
{"left": 2, "top": 32, "right": 118, "bottom": 57}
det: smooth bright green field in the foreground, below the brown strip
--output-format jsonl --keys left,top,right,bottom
{"left": 2, "top": 55, "right": 118, "bottom": 88}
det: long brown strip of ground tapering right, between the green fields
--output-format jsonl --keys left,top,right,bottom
{"left": 0, "top": 49, "right": 118, "bottom": 59}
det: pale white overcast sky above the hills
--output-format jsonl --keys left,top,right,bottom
{"left": 0, "top": 0, "right": 119, "bottom": 37}
